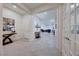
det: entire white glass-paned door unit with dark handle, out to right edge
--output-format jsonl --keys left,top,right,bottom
{"left": 63, "top": 4, "right": 79, "bottom": 56}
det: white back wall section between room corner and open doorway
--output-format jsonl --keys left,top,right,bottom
{"left": 22, "top": 14, "right": 34, "bottom": 41}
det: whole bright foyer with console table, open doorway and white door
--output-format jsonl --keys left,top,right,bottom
{"left": 0, "top": 3, "right": 79, "bottom": 56}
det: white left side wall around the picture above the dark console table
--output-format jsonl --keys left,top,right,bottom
{"left": 3, "top": 8, "right": 22, "bottom": 40}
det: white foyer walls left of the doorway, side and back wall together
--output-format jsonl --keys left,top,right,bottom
{"left": 3, "top": 8, "right": 34, "bottom": 40}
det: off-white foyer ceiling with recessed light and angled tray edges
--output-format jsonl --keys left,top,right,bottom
{"left": 3, "top": 3, "right": 62, "bottom": 15}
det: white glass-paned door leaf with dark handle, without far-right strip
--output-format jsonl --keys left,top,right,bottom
{"left": 63, "top": 4, "right": 76, "bottom": 56}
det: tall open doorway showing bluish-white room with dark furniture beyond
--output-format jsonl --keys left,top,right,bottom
{"left": 32, "top": 9, "right": 58, "bottom": 55}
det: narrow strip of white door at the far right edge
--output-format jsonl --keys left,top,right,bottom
{"left": 76, "top": 4, "right": 79, "bottom": 56}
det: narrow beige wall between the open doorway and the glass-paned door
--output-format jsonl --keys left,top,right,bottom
{"left": 56, "top": 5, "right": 64, "bottom": 54}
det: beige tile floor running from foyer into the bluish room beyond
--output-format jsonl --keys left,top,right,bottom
{"left": 3, "top": 33, "right": 59, "bottom": 56}
